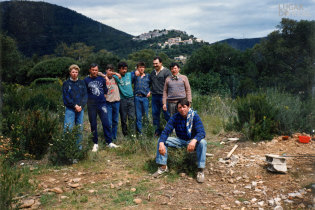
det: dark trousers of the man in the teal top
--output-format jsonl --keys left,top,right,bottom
{"left": 119, "top": 97, "right": 136, "bottom": 136}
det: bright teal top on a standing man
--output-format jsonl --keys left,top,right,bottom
{"left": 113, "top": 72, "right": 135, "bottom": 99}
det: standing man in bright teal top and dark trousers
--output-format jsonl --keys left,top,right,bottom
{"left": 113, "top": 62, "right": 135, "bottom": 136}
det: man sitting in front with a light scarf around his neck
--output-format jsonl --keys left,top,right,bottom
{"left": 153, "top": 99, "right": 207, "bottom": 183}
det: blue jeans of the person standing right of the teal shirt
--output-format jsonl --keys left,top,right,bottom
{"left": 135, "top": 96, "right": 149, "bottom": 133}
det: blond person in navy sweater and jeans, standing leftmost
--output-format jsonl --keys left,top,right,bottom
{"left": 62, "top": 64, "right": 87, "bottom": 149}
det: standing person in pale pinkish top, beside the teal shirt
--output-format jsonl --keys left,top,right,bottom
{"left": 98, "top": 64, "right": 121, "bottom": 141}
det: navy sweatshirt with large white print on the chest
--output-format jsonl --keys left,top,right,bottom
{"left": 84, "top": 76, "right": 108, "bottom": 104}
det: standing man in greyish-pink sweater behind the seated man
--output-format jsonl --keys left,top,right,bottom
{"left": 163, "top": 63, "right": 192, "bottom": 116}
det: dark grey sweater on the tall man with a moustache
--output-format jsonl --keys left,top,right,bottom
{"left": 150, "top": 67, "right": 172, "bottom": 95}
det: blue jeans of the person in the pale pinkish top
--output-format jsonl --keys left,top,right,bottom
{"left": 106, "top": 101, "right": 120, "bottom": 139}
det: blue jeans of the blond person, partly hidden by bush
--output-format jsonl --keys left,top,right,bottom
{"left": 63, "top": 107, "right": 84, "bottom": 148}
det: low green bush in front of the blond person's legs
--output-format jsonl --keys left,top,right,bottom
{"left": 49, "top": 126, "right": 88, "bottom": 165}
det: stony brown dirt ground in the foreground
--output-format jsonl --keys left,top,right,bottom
{"left": 17, "top": 134, "right": 315, "bottom": 209}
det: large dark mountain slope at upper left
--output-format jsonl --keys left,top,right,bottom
{"left": 0, "top": 1, "right": 137, "bottom": 56}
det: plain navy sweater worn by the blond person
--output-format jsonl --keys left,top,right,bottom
{"left": 62, "top": 79, "right": 87, "bottom": 109}
